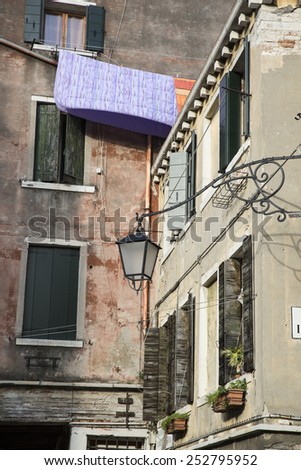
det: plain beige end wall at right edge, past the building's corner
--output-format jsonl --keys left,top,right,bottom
{"left": 252, "top": 3, "right": 301, "bottom": 415}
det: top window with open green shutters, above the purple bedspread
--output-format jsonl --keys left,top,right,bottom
{"left": 24, "top": 0, "right": 105, "bottom": 52}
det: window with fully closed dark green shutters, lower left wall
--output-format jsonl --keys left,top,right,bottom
{"left": 22, "top": 245, "right": 80, "bottom": 340}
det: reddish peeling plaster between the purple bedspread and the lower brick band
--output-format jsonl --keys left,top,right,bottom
{"left": 0, "top": 41, "right": 147, "bottom": 382}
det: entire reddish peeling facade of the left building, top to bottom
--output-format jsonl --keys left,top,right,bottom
{"left": 0, "top": 0, "right": 238, "bottom": 449}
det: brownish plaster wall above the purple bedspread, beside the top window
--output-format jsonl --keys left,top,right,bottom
{"left": 0, "top": 0, "right": 235, "bottom": 78}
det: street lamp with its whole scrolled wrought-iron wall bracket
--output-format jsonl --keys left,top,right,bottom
{"left": 116, "top": 152, "right": 301, "bottom": 292}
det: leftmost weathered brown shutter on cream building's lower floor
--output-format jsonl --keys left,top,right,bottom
{"left": 143, "top": 328, "right": 160, "bottom": 421}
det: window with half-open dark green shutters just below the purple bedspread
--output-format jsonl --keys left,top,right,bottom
{"left": 34, "top": 103, "right": 85, "bottom": 185}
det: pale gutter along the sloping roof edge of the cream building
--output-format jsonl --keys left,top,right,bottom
{"left": 151, "top": 0, "right": 247, "bottom": 176}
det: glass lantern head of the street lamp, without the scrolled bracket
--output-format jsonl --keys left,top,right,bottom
{"left": 116, "top": 219, "right": 161, "bottom": 293}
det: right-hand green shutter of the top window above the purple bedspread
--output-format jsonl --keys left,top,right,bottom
{"left": 86, "top": 5, "right": 105, "bottom": 52}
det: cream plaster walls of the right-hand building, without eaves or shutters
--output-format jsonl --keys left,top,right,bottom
{"left": 152, "top": 6, "right": 301, "bottom": 449}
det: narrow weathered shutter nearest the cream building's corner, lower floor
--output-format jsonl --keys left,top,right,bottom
{"left": 242, "top": 236, "right": 254, "bottom": 372}
